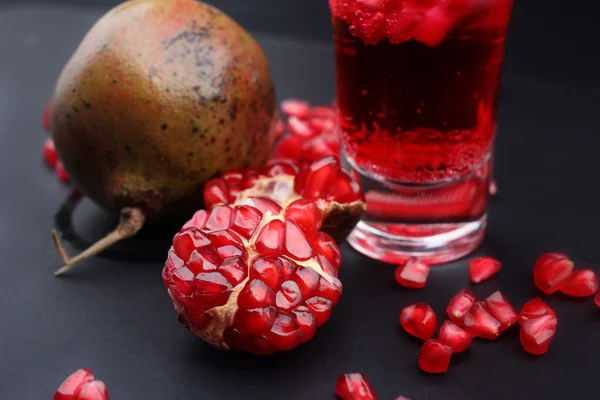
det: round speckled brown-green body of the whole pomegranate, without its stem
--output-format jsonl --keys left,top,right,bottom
{"left": 51, "top": 0, "right": 278, "bottom": 220}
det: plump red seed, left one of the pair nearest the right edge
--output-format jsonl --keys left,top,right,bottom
{"left": 533, "top": 253, "right": 573, "bottom": 294}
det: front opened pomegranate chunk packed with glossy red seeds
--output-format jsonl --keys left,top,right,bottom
{"left": 163, "top": 204, "right": 342, "bottom": 355}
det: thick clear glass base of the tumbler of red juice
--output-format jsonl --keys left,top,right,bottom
{"left": 348, "top": 215, "right": 487, "bottom": 265}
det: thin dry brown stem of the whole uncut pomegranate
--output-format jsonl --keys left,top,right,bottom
{"left": 52, "top": 207, "right": 146, "bottom": 276}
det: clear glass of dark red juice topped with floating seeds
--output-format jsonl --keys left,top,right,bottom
{"left": 329, "top": 0, "right": 513, "bottom": 264}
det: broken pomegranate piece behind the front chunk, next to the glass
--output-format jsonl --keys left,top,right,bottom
{"left": 204, "top": 156, "right": 365, "bottom": 243}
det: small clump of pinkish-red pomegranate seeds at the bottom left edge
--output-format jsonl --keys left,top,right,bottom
{"left": 54, "top": 368, "right": 109, "bottom": 400}
